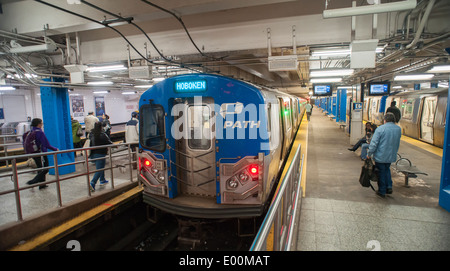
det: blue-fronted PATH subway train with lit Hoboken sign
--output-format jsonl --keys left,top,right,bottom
{"left": 138, "top": 74, "right": 306, "bottom": 218}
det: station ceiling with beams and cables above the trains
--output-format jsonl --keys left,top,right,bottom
{"left": 0, "top": 0, "right": 450, "bottom": 97}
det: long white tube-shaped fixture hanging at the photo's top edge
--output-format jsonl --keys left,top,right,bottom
{"left": 323, "top": 0, "right": 417, "bottom": 19}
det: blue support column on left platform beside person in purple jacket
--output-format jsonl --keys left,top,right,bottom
{"left": 40, "top": 78, "right": 75, "bottom": 175}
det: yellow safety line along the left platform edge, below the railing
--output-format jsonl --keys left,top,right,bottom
{"left": 10, "top": 186, "right": 143, "bottom": 251}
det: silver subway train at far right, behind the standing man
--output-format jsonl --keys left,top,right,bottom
{"left": 363, "top": 88, "right": 448, "bottom": 148}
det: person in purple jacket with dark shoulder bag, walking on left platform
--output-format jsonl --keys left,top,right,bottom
{"left": 23, "top": 118, "right": 58, "bottom": 189}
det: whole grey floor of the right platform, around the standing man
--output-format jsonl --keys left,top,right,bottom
{"left": 297, "top": 107, "right": 450, "bottom": 251}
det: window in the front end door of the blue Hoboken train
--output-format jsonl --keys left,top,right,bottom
{"left": 188, "top": 105, "right": 211, "bottom": 150}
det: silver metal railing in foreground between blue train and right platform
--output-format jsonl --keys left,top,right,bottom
{"left": 250, "top": 146, "right": 304, "bottom": 251}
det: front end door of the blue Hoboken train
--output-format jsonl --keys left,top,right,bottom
{"left": 171, "top": 97, "right": 216, "bottom": 197}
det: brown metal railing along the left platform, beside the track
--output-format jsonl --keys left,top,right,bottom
{"left": 0, "top": 143, "right": 137, "bottom": 221}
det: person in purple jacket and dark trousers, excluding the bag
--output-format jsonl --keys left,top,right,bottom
{"left": 27, "top": 118, "right": 58, "bottom": 189}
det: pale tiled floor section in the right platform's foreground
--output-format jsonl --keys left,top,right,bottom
{"left": 297, "top": 198, "right": 450, "bottom": 251}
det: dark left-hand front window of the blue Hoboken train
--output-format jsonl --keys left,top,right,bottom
{"left": 139, "top": 104, "right": 166, "bottom": 152}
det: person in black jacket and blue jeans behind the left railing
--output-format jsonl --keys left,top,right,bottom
{"left": 89, "top": 122, "right": 113, "bottom": 191}
